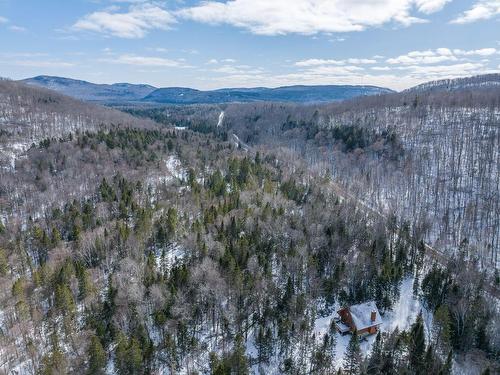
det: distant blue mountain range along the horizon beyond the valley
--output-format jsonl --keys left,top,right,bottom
{"left": 23, "top": 76, "right": 393, "bottom": 104}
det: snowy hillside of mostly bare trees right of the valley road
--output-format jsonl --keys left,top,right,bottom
{"left": 128, "top": 81, "right": 500, "bottom": 269}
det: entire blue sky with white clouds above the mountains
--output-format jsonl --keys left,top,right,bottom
{"left": 0, "top": 0, "right": 500, "bottom": 90}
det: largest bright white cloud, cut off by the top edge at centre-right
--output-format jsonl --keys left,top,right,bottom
{"left": 176, "top": 0, "right": 448, "bottom": 35}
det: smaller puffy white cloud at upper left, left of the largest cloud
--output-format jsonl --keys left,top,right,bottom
{"left": 73, "top": 3, "right": 176, "bottom": 39}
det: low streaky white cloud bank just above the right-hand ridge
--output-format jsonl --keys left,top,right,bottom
{"left": 282, "top": 47, "right": 500, "bottom": 89}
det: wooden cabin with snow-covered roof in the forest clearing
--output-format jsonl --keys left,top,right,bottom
{"left": 336, "top": 301, "right": 382, "bottom": 336}
